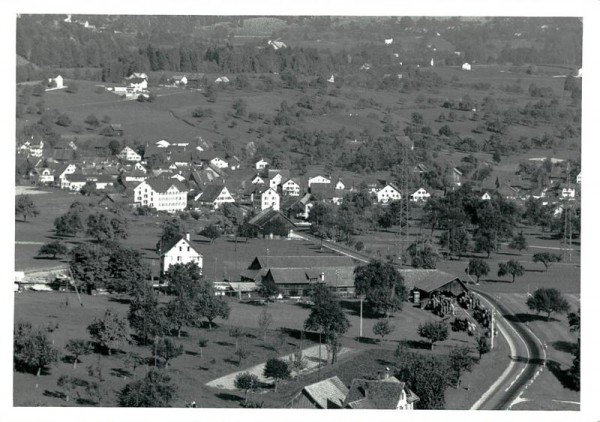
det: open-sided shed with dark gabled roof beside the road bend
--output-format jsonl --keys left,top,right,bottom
{"left": 398, "top": 269, "right": 469, "bottom": 298}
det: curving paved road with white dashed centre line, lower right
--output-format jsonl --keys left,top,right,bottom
{"left": 471, "top": 291, "right": 546, "bottom": 410}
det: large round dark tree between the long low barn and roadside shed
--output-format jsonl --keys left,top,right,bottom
{"left": 354, "top": 260, "right": 407, "bottom": 315}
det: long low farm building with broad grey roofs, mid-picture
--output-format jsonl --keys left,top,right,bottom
{"left": 242, "top": 255, "right": 355, "bottom": 297}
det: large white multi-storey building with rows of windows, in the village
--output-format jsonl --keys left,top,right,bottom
{"left": 134, "top": 178, "right": 188, "bottom": 213}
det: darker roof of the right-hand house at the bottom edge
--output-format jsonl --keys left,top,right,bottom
{"left": 344, "top": 377, "right": 405, "bottom": 409}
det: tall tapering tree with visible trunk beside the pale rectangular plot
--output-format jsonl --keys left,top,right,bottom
{"left": 304, "top": 284, "right": 350, "bottom": 364}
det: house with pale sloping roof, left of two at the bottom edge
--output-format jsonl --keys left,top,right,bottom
{"left": 285, "top": 376, "right": 348, "bottom": 409}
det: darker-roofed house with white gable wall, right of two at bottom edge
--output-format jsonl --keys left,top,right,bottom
{"left": 343, "top": 369, "right": 419, "bottom": 410}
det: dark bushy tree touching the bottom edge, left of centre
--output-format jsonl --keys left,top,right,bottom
{"left": 119, "top": 369, "right": 177, "bottom": 407}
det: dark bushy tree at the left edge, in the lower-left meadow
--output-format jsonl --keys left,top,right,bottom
{"left": 13, "top": 321, "right": 58, "bottom": 376}
